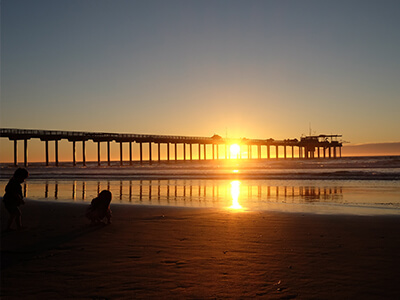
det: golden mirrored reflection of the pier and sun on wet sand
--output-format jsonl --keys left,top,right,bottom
{"left": 17, "top": 180, "right": 343, "bottom": 209}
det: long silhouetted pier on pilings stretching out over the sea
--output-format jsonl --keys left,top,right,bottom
{"left": 0, "top": 128, "right": 342, "bottom": 166}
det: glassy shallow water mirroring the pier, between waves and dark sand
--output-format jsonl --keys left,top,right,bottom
{"left": 0, "top": 179, "right": 400, "bottom": 215}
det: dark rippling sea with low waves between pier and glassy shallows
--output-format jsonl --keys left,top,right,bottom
{"left": 0, "top": 156, "right": 400, "bottom": 180}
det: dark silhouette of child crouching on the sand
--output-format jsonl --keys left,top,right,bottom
{"left": 86, "top": 190, "right": 112, "bottom": 224}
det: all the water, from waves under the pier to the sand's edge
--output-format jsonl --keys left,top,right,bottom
{"left": 0, "top": 156, "right": 400, "bottom": 215}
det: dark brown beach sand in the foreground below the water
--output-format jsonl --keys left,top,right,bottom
{"left": 1, "top": 200, "right": 400, "bottom": 299}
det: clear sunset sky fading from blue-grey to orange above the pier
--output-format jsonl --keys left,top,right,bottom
{"left": 0, "top": 0, "right": 400, "bottom": 159}
